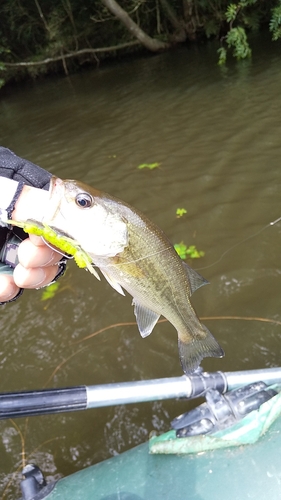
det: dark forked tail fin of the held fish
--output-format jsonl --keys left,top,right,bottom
{"left": 178, "top": 325, "right": 224, "bottom": 374}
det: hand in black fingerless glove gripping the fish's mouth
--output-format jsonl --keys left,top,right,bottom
{"left": 0, "top": 160, "right": 65, "bottom": 303}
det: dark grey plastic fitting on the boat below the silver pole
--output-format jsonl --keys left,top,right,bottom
{"left": 171, "top": 382, "right": 277, "bottom": 438}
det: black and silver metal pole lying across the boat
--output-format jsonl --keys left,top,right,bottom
{"left": 0, "top": 368, "right": 281, "bottom": 420}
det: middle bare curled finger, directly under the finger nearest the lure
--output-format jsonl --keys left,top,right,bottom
{"left": 14, "top": 264, "right": 59, "bottom": 288}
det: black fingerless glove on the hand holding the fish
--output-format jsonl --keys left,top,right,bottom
{"left": 0, "top": 146, "right": 66, "bottom": 304}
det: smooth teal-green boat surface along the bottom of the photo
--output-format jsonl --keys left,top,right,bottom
{"left": 43, "top": 418, "right": 281, "bottom": 500}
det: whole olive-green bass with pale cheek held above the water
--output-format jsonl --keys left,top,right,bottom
{"left": 44, "top": 178, "right": 224, "bottom": 374}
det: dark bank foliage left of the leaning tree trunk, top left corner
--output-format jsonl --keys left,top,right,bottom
{"left": 0, "top": 0, "right": 138, "bottom": 85}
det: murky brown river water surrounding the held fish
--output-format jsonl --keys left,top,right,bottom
{"left": 0, "top": 34, "right": 281, "bottom": 499}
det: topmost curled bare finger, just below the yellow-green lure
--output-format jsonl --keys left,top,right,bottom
{"left": 18, "top": 236, "right": 61, "bottom": 268}
